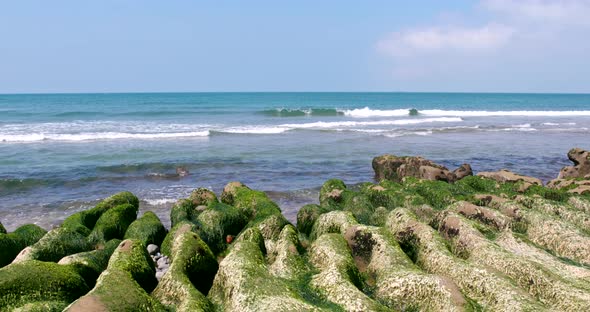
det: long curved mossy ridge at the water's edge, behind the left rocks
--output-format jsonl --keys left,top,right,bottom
{"left": 61, "top": 192, "right": 139, "bottom": 236}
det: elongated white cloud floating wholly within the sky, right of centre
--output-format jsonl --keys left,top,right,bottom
{"left": 377, "top": 24, "right": 514, "bottom": 57}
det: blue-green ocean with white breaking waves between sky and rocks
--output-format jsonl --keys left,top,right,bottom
{"left": 0, "top": 93, "right": 590, "bottom": 230}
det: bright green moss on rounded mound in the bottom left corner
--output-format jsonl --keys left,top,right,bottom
{"left": 0, "top": 260, "right": 89, "bottom": 311}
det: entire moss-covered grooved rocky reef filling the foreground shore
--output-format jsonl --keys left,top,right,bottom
{"left": 0, "top": 152, "right": 590, "bottom": 311}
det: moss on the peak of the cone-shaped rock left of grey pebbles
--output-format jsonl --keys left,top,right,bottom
{"left": 107, "top": 239, "right": 158, "bottom": 293}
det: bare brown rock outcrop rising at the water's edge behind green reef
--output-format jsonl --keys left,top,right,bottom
{"left": 373, "top": 154, "right": 473, "bottom": 183}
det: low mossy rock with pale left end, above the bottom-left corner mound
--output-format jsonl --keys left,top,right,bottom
{"left": 14, "top": 228, "right": 92, "bottom": 262}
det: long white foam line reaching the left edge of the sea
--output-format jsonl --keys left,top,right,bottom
{"left": 0, "top": 131, "right": 209, "bottom": 142}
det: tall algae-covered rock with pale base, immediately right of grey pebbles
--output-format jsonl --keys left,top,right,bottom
{"left": 152, "top": 231, "right": 218, "bottom": 311}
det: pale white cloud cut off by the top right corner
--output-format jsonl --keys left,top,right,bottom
{"left": 482, "top": 0, "right": 590, "bottom": 25}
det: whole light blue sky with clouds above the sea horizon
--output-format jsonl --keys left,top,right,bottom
{"left": 0, "top": 0, "right": 590, "bottom": 93}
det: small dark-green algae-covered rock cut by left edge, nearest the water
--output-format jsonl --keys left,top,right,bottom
{"left": 0, "top": 224, "right": 47, "bottom": 267}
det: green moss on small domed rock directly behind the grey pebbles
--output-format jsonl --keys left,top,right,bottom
{"left": 124, "top": 211, "right": 166, "bottom": 246}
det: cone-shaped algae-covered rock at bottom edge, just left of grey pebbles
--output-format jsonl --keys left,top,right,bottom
{"left": 65, "top": 239, "right": 166, "bottom": 311}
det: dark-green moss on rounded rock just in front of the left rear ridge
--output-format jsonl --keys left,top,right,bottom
{"left": 88, "top": 204, "right": 137, "bottom": 244}
